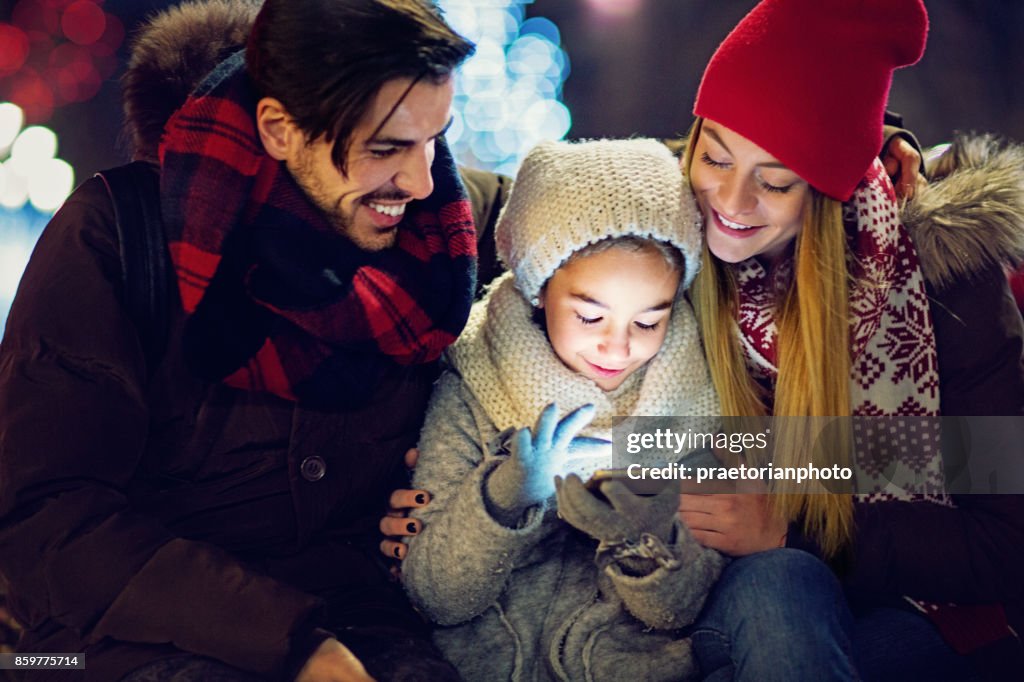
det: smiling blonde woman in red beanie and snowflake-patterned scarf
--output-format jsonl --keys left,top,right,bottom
{"left": 680, "top": 0, "right": 1024, "bottom": 680}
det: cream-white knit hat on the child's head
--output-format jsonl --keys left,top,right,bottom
{"left": 496, "top": 139, "right": 701, "bottom": 305}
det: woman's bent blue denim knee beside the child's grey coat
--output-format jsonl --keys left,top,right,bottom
{"left": 691, "top": 549, "right": 858, "bottom": 682}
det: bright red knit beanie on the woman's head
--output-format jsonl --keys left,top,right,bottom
{"left": 693, "top": 0, "right": 928, "bottom": 201}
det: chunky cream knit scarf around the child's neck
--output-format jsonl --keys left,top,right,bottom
{"left": 449, "top": 273, "right": 720, "bottom": 473}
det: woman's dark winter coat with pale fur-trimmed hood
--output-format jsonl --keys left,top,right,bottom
{"left": 827, "top": 138, "right": 1024, "bottom": 655}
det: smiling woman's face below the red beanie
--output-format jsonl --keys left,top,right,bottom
{"left": 690, "top": 120, "right": 811, "bottom": 263}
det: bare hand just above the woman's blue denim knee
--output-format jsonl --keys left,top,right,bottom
{"left": 679, "top": 493, "right": 787, "bottom": 556}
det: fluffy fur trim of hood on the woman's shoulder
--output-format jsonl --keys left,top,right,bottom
{"left": 902, "top": 135, "right": 1024, "bottom": 290}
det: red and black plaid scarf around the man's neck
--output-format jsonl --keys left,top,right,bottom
{"left": 161, "top": 53, "right": 476, "bottom": 404}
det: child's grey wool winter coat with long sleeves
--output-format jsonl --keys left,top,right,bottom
{"left": 402, "top": 372, "right": 725, "bottom": 682}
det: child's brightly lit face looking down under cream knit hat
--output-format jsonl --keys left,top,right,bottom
{"left": 539, "top": 247, "right": 680, "bottom": 391}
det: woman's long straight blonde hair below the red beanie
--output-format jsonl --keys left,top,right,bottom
{"left": 683, "top": 119, "right": 853, "bottom": 556}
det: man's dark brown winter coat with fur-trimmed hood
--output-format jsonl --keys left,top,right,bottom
{"left": 0, "top": 3, "right": 507, "bottom": 682}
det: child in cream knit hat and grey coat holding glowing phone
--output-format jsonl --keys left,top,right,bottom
{"left": 402, "top": 139, "right": 724, "bottom": 681}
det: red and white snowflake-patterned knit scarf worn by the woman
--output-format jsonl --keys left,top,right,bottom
{"left": 736, "top": 161, "right": 942, "bottom": 499}
